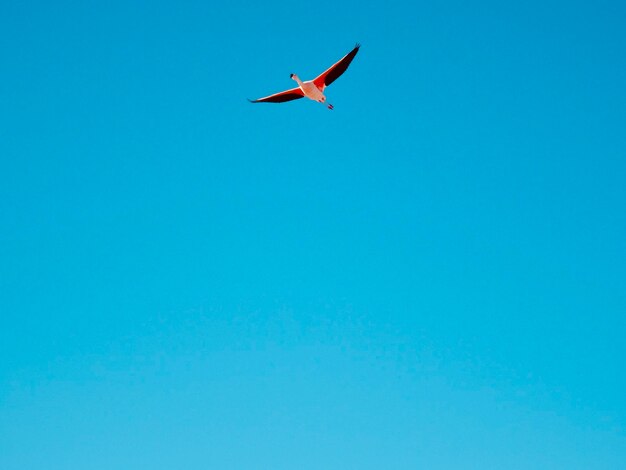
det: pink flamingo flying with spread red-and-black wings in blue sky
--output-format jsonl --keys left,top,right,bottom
{"left": 248, "top": 44, "right": 361, "bottom": 109}
